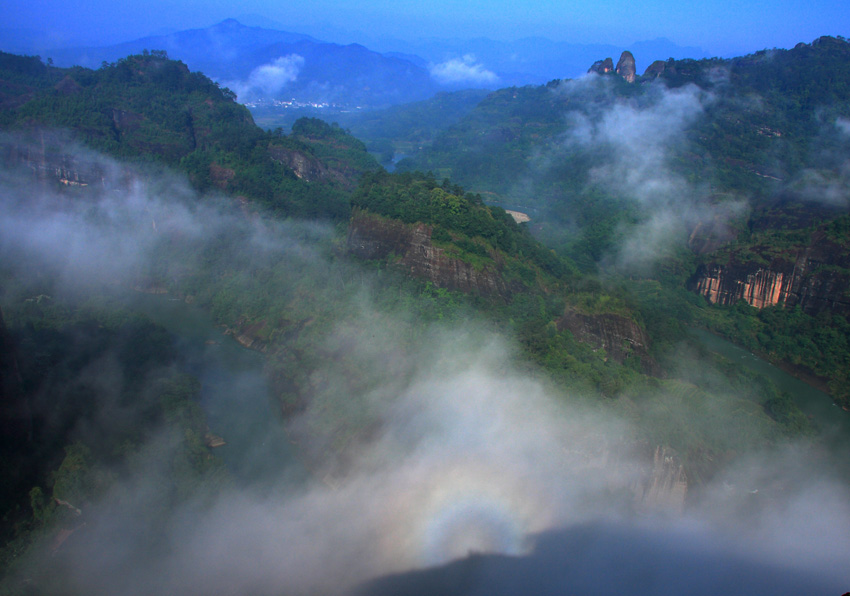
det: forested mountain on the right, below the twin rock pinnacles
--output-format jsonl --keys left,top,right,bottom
{"left": 401, "top": 37, "right": 850, "bottom": 408}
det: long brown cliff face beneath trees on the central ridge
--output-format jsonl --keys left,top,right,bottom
{"left": 347, "top": 212, "right": 515, "bottom": 300}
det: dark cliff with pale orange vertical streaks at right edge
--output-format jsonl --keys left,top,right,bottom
{"left": 688, "top": 233, "right": 850, "bottom": 316}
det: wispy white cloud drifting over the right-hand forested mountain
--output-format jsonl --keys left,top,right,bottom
{"left": 539, "top": 75, "right": 748, "bottom": 273}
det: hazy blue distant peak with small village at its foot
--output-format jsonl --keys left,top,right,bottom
{"left": 42, "top": 19, "right": 439, "bottom": 108}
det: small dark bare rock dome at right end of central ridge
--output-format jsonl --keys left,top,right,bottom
{"left": 557, "top": 307, "right": 660, "bottom": 375}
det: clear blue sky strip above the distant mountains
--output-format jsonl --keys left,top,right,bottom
{"left": 0, "top": 0, "right": 850, "bottom": 56}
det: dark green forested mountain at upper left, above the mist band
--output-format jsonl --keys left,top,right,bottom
{"left": 0, "top": 52, "right": 379, "bottom": 218}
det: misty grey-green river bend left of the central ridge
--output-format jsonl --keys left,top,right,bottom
{"left": 131, "top": 294, "right": 307, "bottom": 487}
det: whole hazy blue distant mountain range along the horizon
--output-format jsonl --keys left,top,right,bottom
{"left": 29, "top": 19, "right": 703, "bottom": 108}
